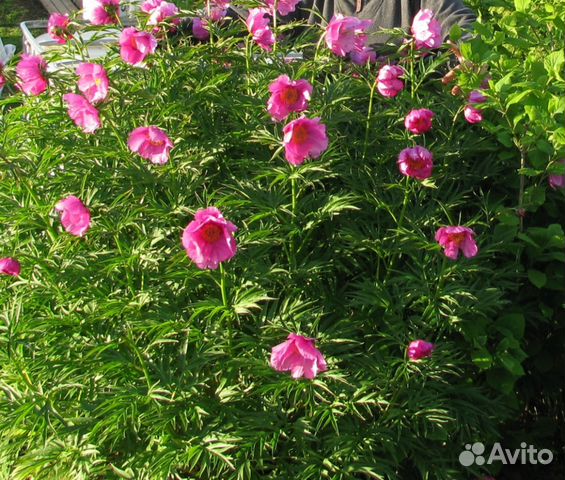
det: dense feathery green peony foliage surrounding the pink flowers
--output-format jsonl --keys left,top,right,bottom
{"left": 0, "top": 3, "right": 565, "bottom": 480}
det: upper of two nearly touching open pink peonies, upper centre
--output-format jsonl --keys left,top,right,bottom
{"left": 267, "top": 75, "right": 312, "bottom": 122}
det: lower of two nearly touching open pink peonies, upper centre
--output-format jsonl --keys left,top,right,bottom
{"left": 283, "top": 117, "right": 328, "bottom": 165}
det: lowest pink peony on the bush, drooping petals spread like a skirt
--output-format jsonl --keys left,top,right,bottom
{"left": 271, "top": 333, "right": 328, "bottom": 380}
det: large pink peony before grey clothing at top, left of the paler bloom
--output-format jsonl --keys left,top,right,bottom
{"left": 326, "top": 13, "right": 373, "bottom": 57}
